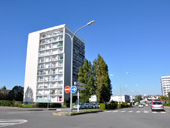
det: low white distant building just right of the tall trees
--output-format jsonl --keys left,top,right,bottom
{"left": 110, "top": 95, "right": 130, "bottom": 102}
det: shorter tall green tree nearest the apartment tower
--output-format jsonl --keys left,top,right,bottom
{"left": 78, "top": 59, "right": 95, "bottom": 103}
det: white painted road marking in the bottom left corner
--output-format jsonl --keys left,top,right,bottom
{"left": 0, "top": 119, "right": 27, "bottom": 127}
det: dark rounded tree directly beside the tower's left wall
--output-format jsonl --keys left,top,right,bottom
{"left": 8, "top": 86, "right": 24, "bottom": 101}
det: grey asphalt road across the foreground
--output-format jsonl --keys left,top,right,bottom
{"left": 0, "top": 107, "right": 170, "bottom": 128}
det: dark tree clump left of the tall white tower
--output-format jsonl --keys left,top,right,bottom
{"left": 0, "top": 86, "right": 24, "bottom": 101}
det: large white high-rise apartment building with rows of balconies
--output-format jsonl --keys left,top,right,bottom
{"left": 24, "top": 24, "right": 85, "bottom": 103}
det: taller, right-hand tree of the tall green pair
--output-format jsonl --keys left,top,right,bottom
{"left": 93, "top": 55, "right": 112, "bottom": 103}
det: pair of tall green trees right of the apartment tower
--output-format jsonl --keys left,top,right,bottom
{"left": 78, "top": 55, "right": 112, "bottom": 103}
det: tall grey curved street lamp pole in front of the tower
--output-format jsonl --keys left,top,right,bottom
{"left": 70, "top": 20, "right": 95, "bottom": 112}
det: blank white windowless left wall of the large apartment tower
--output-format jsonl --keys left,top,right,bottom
{"left": 24, "top": 32, "right": 39, "bottom": 102}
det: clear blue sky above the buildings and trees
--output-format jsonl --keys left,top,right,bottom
{"left": 0, "top": 0, "right": 170, "bottom": 95}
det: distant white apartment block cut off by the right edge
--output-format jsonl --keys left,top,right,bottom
{"left": 161, "top": 76, "right": 170, "bottom": 96}
